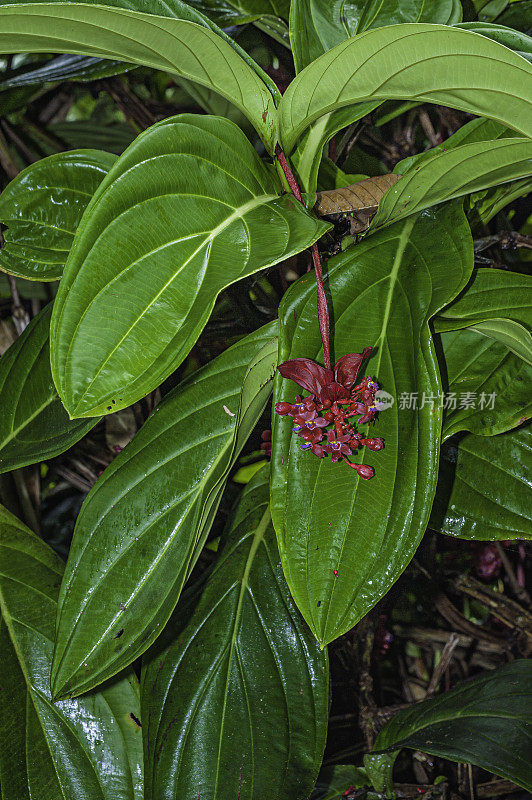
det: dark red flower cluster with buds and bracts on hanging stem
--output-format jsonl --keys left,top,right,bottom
{"left": 275, "top": 347, "right": 384, "bottom": 480}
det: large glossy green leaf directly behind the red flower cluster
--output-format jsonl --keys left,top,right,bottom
{"left": 272, "top": 204, "right": 473, "bottom": 644}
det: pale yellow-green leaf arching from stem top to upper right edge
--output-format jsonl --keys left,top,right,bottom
{"left": 279, "top": 23, "right": 532, "bottom": 152}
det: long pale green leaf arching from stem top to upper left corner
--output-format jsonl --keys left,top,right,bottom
{"left": 0, "top": 0, "right": 278, "bottom": 151}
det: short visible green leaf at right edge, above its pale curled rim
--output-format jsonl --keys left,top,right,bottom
{"left": 434, "top": 269, "right": 532, "bottom": 333}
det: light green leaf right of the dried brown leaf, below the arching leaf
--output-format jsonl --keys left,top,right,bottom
{"left": 371, "top": 138, "right": 532, "bottom": 230}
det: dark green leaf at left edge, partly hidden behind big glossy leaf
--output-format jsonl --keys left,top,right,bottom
{"left": 0, "top": 305, "right": 98, "bottom": 473}
